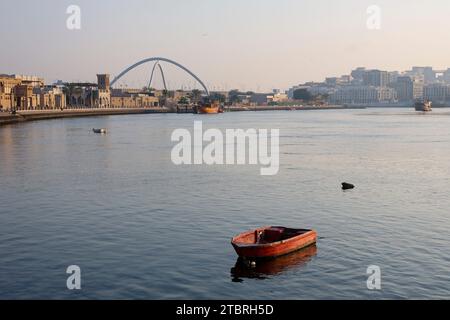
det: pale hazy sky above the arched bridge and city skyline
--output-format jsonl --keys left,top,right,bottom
{"left": 0, "top": 0, "right": 450, "bottom": 91}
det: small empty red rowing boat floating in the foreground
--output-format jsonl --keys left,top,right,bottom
{"left": 231, "top": 227, "right": 317, "bottom": 259}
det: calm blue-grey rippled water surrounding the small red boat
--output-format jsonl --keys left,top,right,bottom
{"left": 0, "top": 109, "right": 450, "bottom": 299}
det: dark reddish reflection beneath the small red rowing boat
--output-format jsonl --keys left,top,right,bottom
{"left": 231, "top": 244, "right": 317, "bottom": 282}
